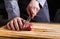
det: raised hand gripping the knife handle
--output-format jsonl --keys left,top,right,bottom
{"left": 26, "top": 0, "right": 40, "bottom": 18}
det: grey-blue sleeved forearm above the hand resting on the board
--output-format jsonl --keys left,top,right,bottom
{"left": 4, "top": 0, "right": 20, "bottom": 20}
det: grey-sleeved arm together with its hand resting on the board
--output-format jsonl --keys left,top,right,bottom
{"left": 4, "top": 0, "right": 23, "bottom": 30}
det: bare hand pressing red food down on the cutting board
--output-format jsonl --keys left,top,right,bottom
{"left": 7, "top": 17, "right": 25, "bottom": 31}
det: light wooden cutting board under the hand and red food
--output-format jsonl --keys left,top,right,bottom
{"left": 0, "top": 23, "right": 60, "bottom": 39}
